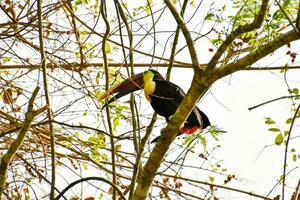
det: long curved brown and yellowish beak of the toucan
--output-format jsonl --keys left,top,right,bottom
{"left": 98, "top": 72, "right": 144, "bottom": 107}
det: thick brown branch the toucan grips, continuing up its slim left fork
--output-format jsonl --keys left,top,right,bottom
{"left": 133, "top": 0, "right": 212, "bottom": 200}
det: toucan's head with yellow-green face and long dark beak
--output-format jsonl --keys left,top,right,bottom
{"left": 98, "top": 69, "right": 164, "bottom": 105}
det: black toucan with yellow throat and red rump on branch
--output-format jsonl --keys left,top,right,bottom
{"left": 99, "top": 69, "right": 210, "bottom": 143}
